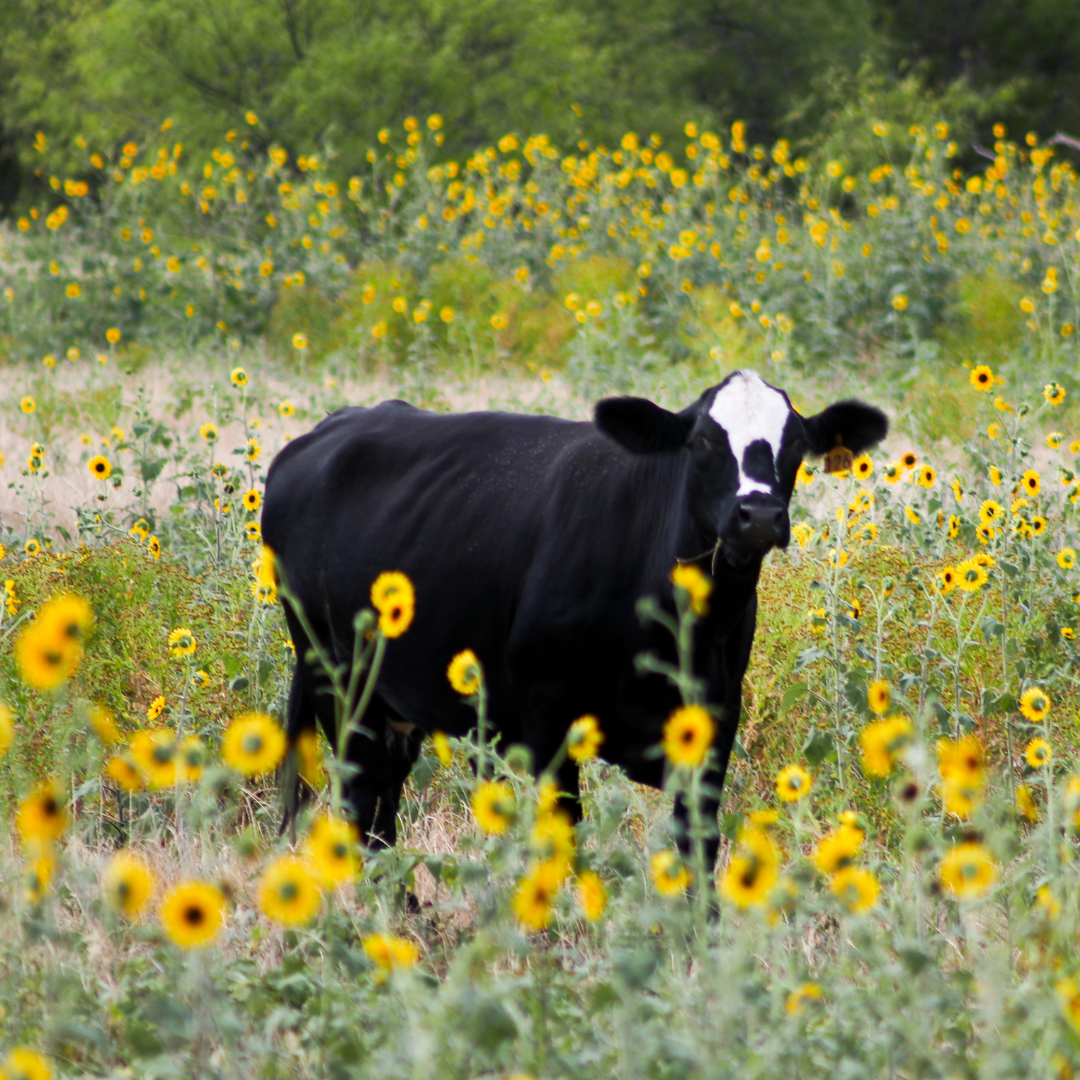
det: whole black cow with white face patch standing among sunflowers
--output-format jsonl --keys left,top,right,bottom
{"left": 262, "top": 372, "right": 888, "bottom": 865}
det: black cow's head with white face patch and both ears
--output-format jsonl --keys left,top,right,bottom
{"left": 596, "top": 372, "right": 889, "bottom": 566}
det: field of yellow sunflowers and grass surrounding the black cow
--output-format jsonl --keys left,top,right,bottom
{"left": 0, "top": 113, "right": 1080, "bottom": 1080}
